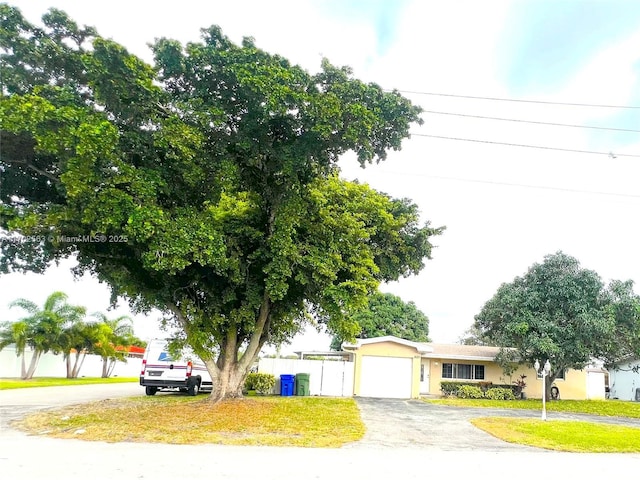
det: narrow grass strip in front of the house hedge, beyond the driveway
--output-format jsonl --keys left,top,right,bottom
{"left": 424, "top": 397, "right": 640, "bottom": 418}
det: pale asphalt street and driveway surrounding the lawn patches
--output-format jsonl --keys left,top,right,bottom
{"left": 0, "top": 384, "right": 640, "bottom": 480}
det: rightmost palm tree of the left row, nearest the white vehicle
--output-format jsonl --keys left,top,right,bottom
{"left": 93, "top": 312, "right": 137, "bottom": 378}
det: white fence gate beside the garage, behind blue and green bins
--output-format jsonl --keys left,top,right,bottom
{"left": 258, "top": 358, "right": 353, "bottom": 397}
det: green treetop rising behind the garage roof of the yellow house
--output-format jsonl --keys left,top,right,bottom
{"left": 331, "top": 292, "right": 429, "bottom": 350}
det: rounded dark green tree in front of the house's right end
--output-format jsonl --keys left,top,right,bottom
{"left": 473, "top": 252, "right": 640, "bottom": 397}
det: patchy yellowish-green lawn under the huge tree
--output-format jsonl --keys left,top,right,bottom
{"left": 14, "top": 394, "right": 365, "bottom": 447}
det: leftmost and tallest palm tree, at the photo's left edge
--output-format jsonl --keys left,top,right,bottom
{"left": 0, "top": 292, "right": 86, "bottom": 380}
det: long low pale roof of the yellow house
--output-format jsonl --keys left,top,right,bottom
{"left": 342, "top": 335, "right": 500, "bottom": 361}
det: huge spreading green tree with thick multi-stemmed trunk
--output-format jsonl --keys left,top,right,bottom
{"left": 0, "top": 5, "right": 440, "bottom": 400}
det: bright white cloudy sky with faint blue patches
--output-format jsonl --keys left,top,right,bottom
{"left": 0, "top": 0, "right": 640, "bottom": 353}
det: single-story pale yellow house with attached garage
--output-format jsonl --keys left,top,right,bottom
{"left": 342, "top": 336, "right": 605, "bottom": 400}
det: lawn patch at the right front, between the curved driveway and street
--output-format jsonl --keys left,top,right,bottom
{"left": 471, "top": 417, "right": 640, "bottom": 453}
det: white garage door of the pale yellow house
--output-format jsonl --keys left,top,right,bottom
{"left": 360, "top": 355, "right": 412, "bottom": 398}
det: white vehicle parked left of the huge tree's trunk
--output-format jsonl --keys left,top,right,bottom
{"left": 140, "top": 339, "right": 213, "bottom": 395}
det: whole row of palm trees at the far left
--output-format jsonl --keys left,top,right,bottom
{"left": 0, "top": 292, "right": 144, "bottom": 380}
